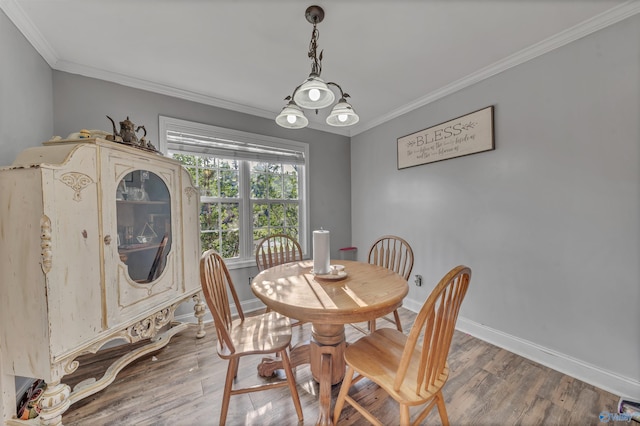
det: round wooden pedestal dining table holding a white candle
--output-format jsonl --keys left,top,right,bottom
{"left": 251, "top": 260, "right": 409, "bottom": 425}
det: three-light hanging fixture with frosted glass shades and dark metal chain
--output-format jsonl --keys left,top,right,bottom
{"left": 276, "top": 6, "right": 360, "bottom": 129}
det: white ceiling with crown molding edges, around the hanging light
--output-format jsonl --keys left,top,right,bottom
{"left": 0, "top": 0, "right": 640, "bottom": 136}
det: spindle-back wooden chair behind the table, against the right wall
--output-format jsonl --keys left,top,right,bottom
{"left": 368, "top": 235, "right": 413, "bottom": 332}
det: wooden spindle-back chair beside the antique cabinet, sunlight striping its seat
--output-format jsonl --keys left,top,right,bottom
{"left": 200, "top": 250, "right": 303, "bottom": 425}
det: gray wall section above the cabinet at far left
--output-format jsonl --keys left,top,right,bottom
{"left": 0, "top": 11, "right": 53, "bottom": 166}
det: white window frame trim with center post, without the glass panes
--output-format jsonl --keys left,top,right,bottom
{"left": 158, "top": 116, "right": 309, "bottom": 269}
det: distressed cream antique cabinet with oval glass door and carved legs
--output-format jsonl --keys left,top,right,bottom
{"left": 0, "top": 139, "right": 204, "bottom": 424}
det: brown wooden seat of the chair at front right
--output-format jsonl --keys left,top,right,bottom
{"left": 344, "top": 328, "right": 449, "bottom": 405}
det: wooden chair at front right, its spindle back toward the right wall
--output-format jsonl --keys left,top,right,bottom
{"left": 333, "top": 266, "right": 471, "bottom": 426}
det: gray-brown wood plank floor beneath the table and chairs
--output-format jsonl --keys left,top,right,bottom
{"left": 63, "top": 308, "right": 618, "bottom": 426}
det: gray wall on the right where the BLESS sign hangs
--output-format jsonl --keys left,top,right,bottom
{"left": 351, "top": 16, "right": 640, "bottom": 397}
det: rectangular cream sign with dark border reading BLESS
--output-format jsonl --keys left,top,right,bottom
{"left": 398, "top": 106, "right": 495, "bottom": 169}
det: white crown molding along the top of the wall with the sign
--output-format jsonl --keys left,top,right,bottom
{"left": 351, "top": 0, "right": 640, "bottom": 136}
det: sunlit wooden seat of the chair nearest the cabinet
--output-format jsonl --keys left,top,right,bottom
{"left": 218, "top": 312, "right": 291, "bottom": 359}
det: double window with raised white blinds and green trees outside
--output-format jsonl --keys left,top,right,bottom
{"left": 160, "top": 117, "right": 308, "bottom": 266}
